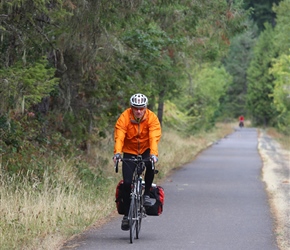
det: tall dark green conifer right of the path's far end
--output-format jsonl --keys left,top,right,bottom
{"left": 247, "top": 25, "right": 276, "bottom": 125}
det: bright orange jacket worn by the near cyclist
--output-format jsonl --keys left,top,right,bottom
{"left": 114, "top": 108, "right": 161, "bottom": 156}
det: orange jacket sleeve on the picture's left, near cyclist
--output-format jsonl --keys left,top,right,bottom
{"left": 114, "top": 113, "right": 127, "bottom": 154}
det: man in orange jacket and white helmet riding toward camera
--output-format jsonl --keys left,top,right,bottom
{"left": 113, "top": 94, "right": 161, "bottom": 230}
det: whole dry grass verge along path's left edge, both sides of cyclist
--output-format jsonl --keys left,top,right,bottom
{"left": 0, "top": 124, "right": 234, "bottom": 250}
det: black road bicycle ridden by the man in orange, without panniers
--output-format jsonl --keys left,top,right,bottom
{"left": 115, "top": 155, "right": 158, "bottom": 243}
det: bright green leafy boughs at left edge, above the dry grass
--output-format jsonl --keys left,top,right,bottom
{"left": 0, "top": 59, "right": 58, "bottom": 113}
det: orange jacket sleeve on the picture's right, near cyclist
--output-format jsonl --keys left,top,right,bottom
{"left": 149, "top": 112, "right": 161, "bottom": 156}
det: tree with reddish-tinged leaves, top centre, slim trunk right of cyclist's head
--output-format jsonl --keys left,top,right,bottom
{"left": 138, "top": 0, "right": 245, "bottom": 125}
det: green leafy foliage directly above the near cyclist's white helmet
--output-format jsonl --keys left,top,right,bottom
{"left": 116, "top": 23, "right": 180, "bottom": 93}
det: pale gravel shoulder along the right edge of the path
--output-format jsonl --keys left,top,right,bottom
{"left": 258, "top": 130, "right": 290, "bottom": 250}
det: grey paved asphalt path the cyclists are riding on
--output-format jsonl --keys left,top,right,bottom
{"left": 63, "top": 128, "right": 278, "bottom": 250}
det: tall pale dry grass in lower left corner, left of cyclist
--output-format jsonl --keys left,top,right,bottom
{"left": 0, "top": 159, "right": 113, "bottom": 250}
